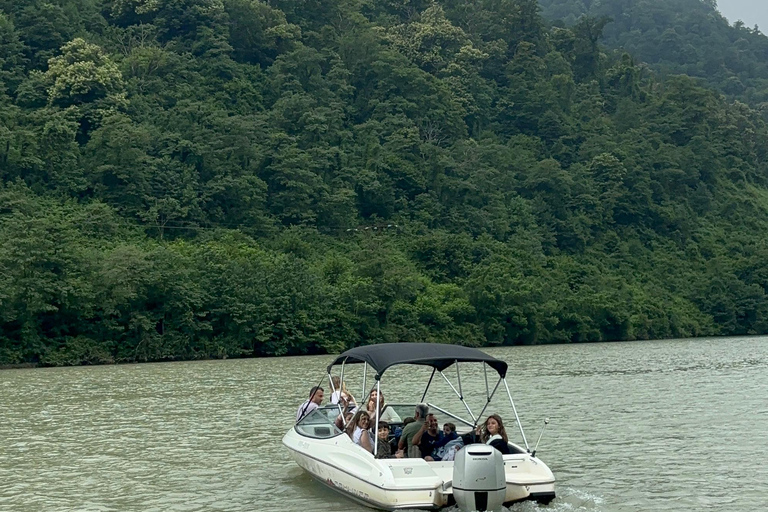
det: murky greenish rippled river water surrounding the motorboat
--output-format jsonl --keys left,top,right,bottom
{"left": 0, "top": 337, "right": 768, "bottom": 512}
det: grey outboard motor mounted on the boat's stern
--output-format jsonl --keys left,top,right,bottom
{"left": 453, "top": 444, "right": 507, "bottom": 512}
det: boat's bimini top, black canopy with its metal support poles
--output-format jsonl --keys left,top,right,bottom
{"left": 320, "top": 343, "right": 538, "bottom": 454}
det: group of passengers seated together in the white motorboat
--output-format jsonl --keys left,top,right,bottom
{"left": 296, "top": 377, "right": 510, "bottom": 461}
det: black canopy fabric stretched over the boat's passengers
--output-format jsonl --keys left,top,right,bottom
{"left": 328, "top": 343, "right": 507, "bottom": 377}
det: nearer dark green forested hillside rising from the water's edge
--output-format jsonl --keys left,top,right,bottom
{"left": 0, "top": 0, "right": 768, "bottom": 365}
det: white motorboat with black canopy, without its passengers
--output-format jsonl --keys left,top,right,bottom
{"left": 283, "top": 343, "right": 555, "bottom": 510}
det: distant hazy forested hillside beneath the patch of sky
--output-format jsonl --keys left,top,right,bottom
{"left": 539, "top": 0, "right": 768, "bottom": 119}
